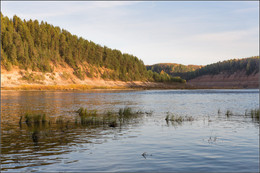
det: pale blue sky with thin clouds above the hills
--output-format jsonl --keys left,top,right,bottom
{"left": 1, "top": 1, "right": 259, "bottom": 65}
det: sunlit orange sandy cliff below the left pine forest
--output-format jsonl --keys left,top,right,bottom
{"left": 1, "top": 66, "right": 186, "bottom": 90}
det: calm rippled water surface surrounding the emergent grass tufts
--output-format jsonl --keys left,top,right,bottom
{"left": 1, "top": 90, "right": 259, "bottom": 172}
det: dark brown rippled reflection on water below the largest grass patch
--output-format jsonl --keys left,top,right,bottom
{"left": 1, "top": 121, "right": 141, "bottom": 170}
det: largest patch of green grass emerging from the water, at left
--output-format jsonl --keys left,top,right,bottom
{"left": 19, "top": 107, "right": 152, "bottom": 127}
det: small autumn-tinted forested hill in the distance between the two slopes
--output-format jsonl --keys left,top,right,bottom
{"left": 146, "top": 63, "right": 202, "bottom": 78}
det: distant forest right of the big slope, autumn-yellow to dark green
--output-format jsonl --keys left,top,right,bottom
{"left": 146, "top": 56, "right": 260, "bottom": 80}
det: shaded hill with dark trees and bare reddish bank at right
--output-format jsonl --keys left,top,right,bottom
{"left": 186, "top": 56, "right": 260, "bottom": 88}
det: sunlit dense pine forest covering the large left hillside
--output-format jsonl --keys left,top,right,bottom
{"left": 1, "top": 13, "right": 185, "bottom": 83}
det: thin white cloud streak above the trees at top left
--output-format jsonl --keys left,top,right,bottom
{"left": 2, "top": 1, "right": 139, "bottom": 18}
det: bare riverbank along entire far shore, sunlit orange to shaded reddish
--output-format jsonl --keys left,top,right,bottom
{"left": 1, "top": 68, "right": 259, "bottom": 90}
